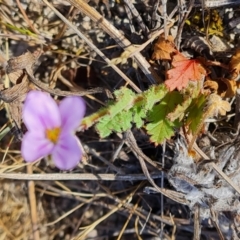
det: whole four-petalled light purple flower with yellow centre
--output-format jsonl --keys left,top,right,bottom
{"left": 21, "top": 91, "right": 86, "bottom": 170}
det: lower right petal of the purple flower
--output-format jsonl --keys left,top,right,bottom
{"left": 52, "top": 134, "right": 82, "bottom": 170}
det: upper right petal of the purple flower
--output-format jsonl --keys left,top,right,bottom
{"left": 59, "top": 96, "right": 86, "bottom": 132}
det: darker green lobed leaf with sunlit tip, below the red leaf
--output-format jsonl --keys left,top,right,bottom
{"left": 146, "top": 92, "right": 182, "bottom": 144}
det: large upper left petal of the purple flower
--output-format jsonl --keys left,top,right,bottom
{"left": 23, "top": 91, "right": 61, "bottom": 131}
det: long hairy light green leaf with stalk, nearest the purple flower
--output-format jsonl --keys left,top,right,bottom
{"left": 81, "top": 85, "right": 168, "bottom": 137}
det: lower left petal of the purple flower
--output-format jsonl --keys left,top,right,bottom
{"left": 21, "top": 131, "right": 54, "bottom": 162}
